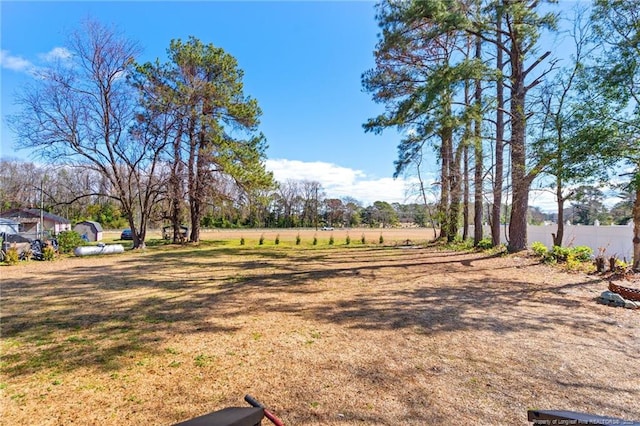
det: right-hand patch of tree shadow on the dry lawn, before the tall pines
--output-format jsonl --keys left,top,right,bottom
{"left": 280, "top": 279, "right": 602, "bottom": 334}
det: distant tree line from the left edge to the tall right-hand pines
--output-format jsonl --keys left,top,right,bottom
{"left": 0, "top": 156, "right": 410, "bottom": 229}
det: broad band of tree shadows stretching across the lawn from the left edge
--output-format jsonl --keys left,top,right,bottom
{"left": 1, "top": 247, "right": 620, "bottom": 375}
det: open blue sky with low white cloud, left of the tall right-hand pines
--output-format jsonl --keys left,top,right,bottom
{"left": 0, "top": 1, "right": 416, "bottom": 204}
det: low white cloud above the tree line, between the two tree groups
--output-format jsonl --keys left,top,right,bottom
{"left": 266, "top": 159, "right": 430, "bottom": 206}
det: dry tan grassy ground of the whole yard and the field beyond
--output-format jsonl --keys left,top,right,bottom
{"left": 0, "top": 230, "right": 640, "bottom": 425}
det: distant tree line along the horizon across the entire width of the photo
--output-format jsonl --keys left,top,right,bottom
{"left": 0, "top": 160, "right": 633, "bottom": 229}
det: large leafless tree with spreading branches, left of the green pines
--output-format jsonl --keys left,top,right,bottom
{"left": 9, "top": 20, "right": 161, "bottom": 247}
